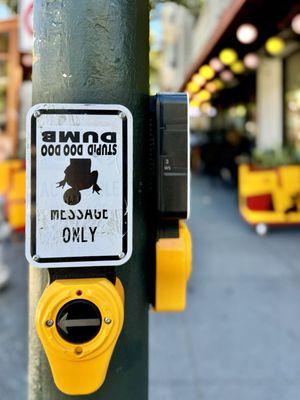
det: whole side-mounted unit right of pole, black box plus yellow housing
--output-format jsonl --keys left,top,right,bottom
{"left": 152, "top": 93, "right": 192, "bottom": 311}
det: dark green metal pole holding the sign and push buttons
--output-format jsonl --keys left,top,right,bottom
{"left": 29, "top": 0, "right": 153, "bottom": 400}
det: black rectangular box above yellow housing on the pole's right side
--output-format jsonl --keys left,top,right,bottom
{"left": 155, "top": 93, "right": 190, "bottom": 219}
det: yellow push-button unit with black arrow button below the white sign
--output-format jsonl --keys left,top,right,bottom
{"left": 36, "top": 278, "right": 124, "bottom": 395}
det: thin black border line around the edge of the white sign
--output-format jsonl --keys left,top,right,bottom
{"left": 30, "top": 108, "right": 128, "bottom": 264}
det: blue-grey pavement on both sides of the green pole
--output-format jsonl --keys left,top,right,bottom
{"left": 0, "top": 178, "right": 300, "bottom": 400}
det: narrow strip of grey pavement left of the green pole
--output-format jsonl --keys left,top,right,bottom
{"left": 0, "top": 236, "right": 27, "bottom": 400}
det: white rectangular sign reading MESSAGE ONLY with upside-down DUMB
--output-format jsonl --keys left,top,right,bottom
{"left": 26, "top": 104, "right": 133, "bottom": 268}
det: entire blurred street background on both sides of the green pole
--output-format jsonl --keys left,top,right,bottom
{"left": 0, "top": 0, "right": 300, "bottom": 400}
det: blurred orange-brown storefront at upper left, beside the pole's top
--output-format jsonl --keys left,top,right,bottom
{"left": 0, "top": 0, "right": 33, "bottom": 158}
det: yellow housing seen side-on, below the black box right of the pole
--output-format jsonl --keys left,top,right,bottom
{"left": 154, "top": 222, "right": 192, "bottom": 311}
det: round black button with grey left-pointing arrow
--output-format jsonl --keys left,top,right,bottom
{"left": 56, "top": 299, "right": 102, "bottom": 344}
